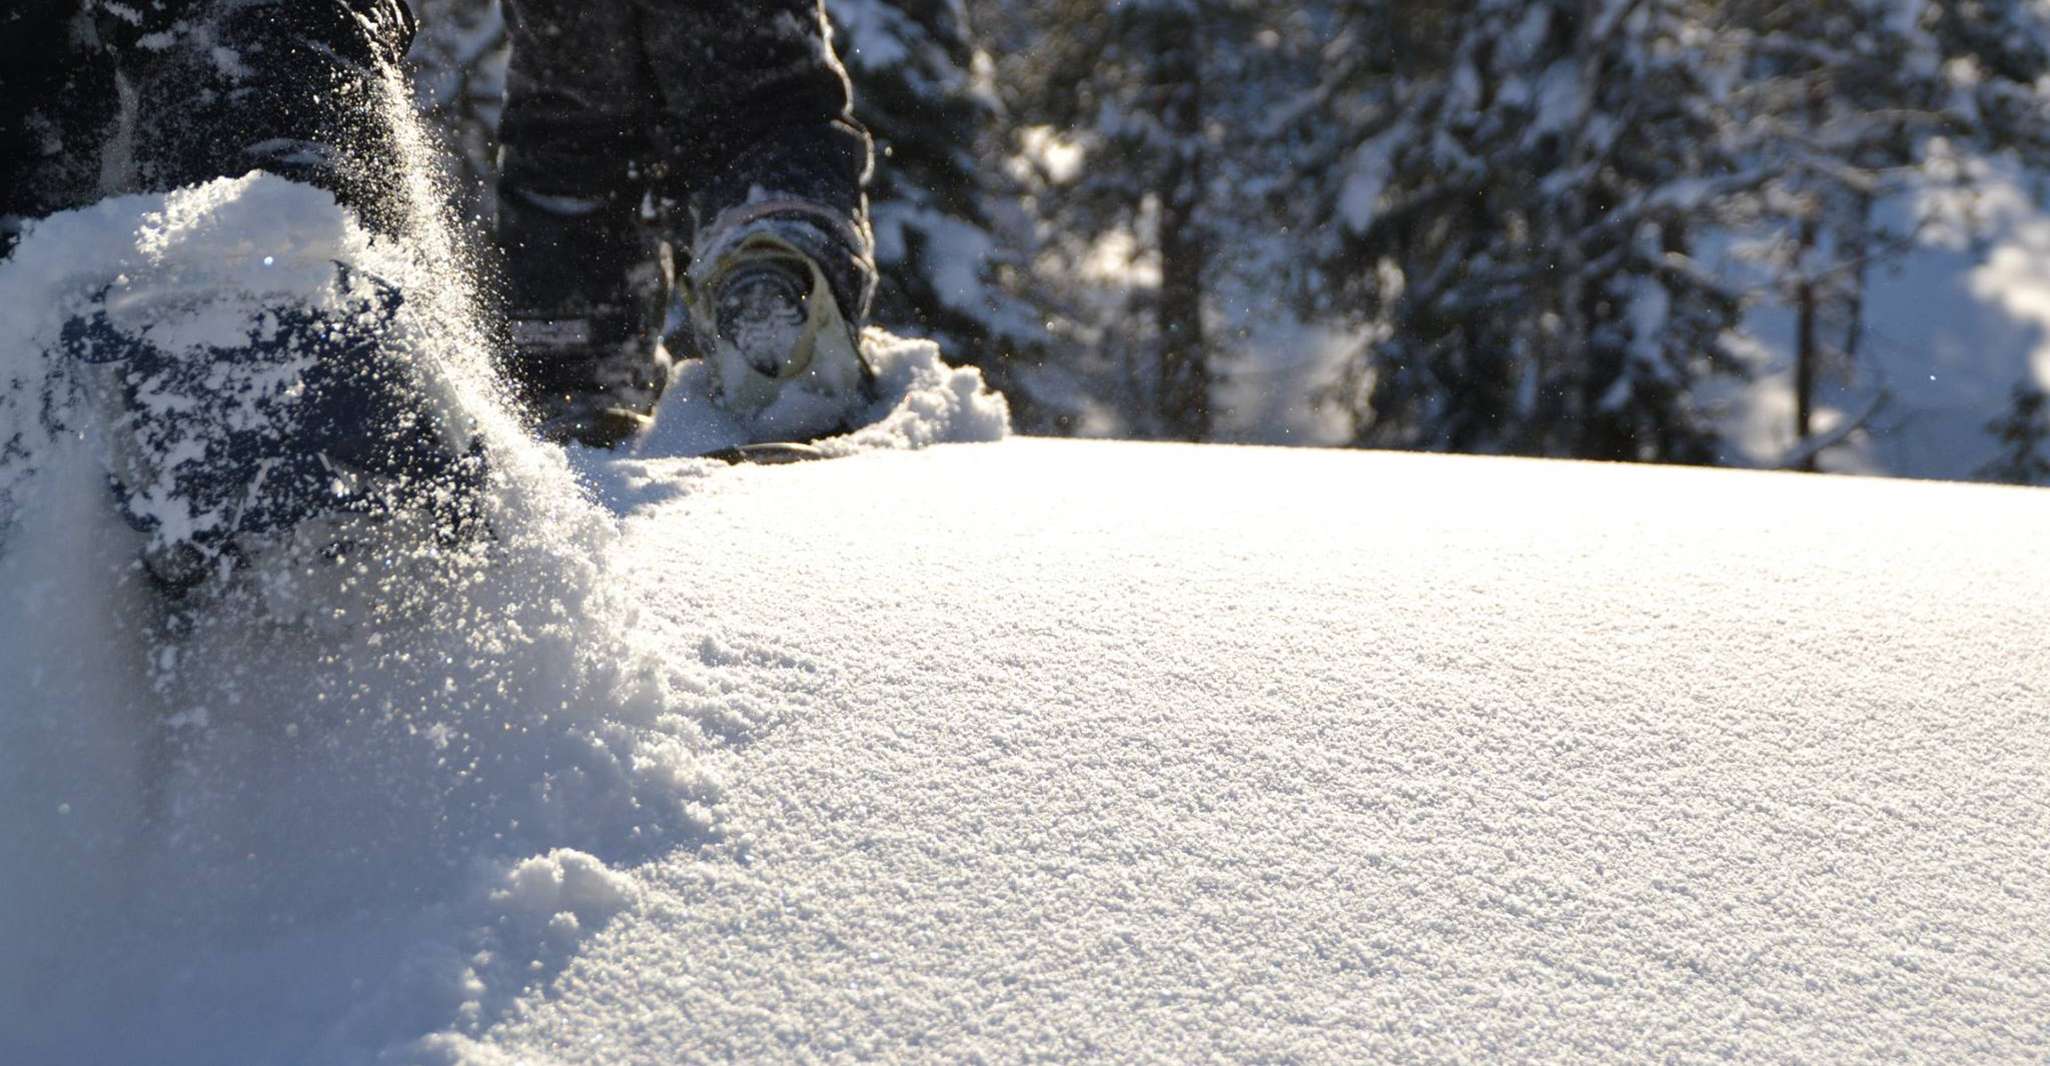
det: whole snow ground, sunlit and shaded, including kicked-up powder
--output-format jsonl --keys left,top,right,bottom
{"left": 0, "top": 180, "right": 2050, "bottom": 1066}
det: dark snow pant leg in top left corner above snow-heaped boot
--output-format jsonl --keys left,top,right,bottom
{"left": 0, "top": 0, "right": 414, "bottom": 257}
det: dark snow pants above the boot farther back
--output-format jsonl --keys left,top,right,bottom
{"left": 498, "top": 0, "right": 875, "bottom": 390}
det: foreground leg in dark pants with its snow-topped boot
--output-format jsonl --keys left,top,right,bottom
{"left": 0, "top": 0, "right": 482, "bottom": 588}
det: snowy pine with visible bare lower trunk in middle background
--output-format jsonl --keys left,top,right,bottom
{"left": 1002, "top": 0, "right": 1285, "bottom": 441}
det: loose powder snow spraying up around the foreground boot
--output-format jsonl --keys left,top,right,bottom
{"left": 0, "top": 174, "right": 724, "bottom": 1064}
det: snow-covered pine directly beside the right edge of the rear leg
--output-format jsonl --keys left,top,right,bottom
{"left": 826, "top": 0, "right": 1046, "bottom": 404}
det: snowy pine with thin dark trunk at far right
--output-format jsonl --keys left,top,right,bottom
{"left": 1718, "top": 0, "right": 2050, "bottom": 469}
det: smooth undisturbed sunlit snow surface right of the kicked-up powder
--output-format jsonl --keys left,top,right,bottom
{"left": 0, "top": 430, "right": 2050, "bottom": 1064}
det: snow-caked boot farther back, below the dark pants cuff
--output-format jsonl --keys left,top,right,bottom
{"left": 691, "top": 223, "right": 875, "bottom": 441}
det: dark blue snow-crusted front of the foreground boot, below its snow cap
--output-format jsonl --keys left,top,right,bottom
{"left": 57, "top": 264, "right": 484, "bottom": 590}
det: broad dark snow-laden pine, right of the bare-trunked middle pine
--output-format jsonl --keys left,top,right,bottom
{"left": 1318, "top": 0, "right": 1753, "bottom": 461}
